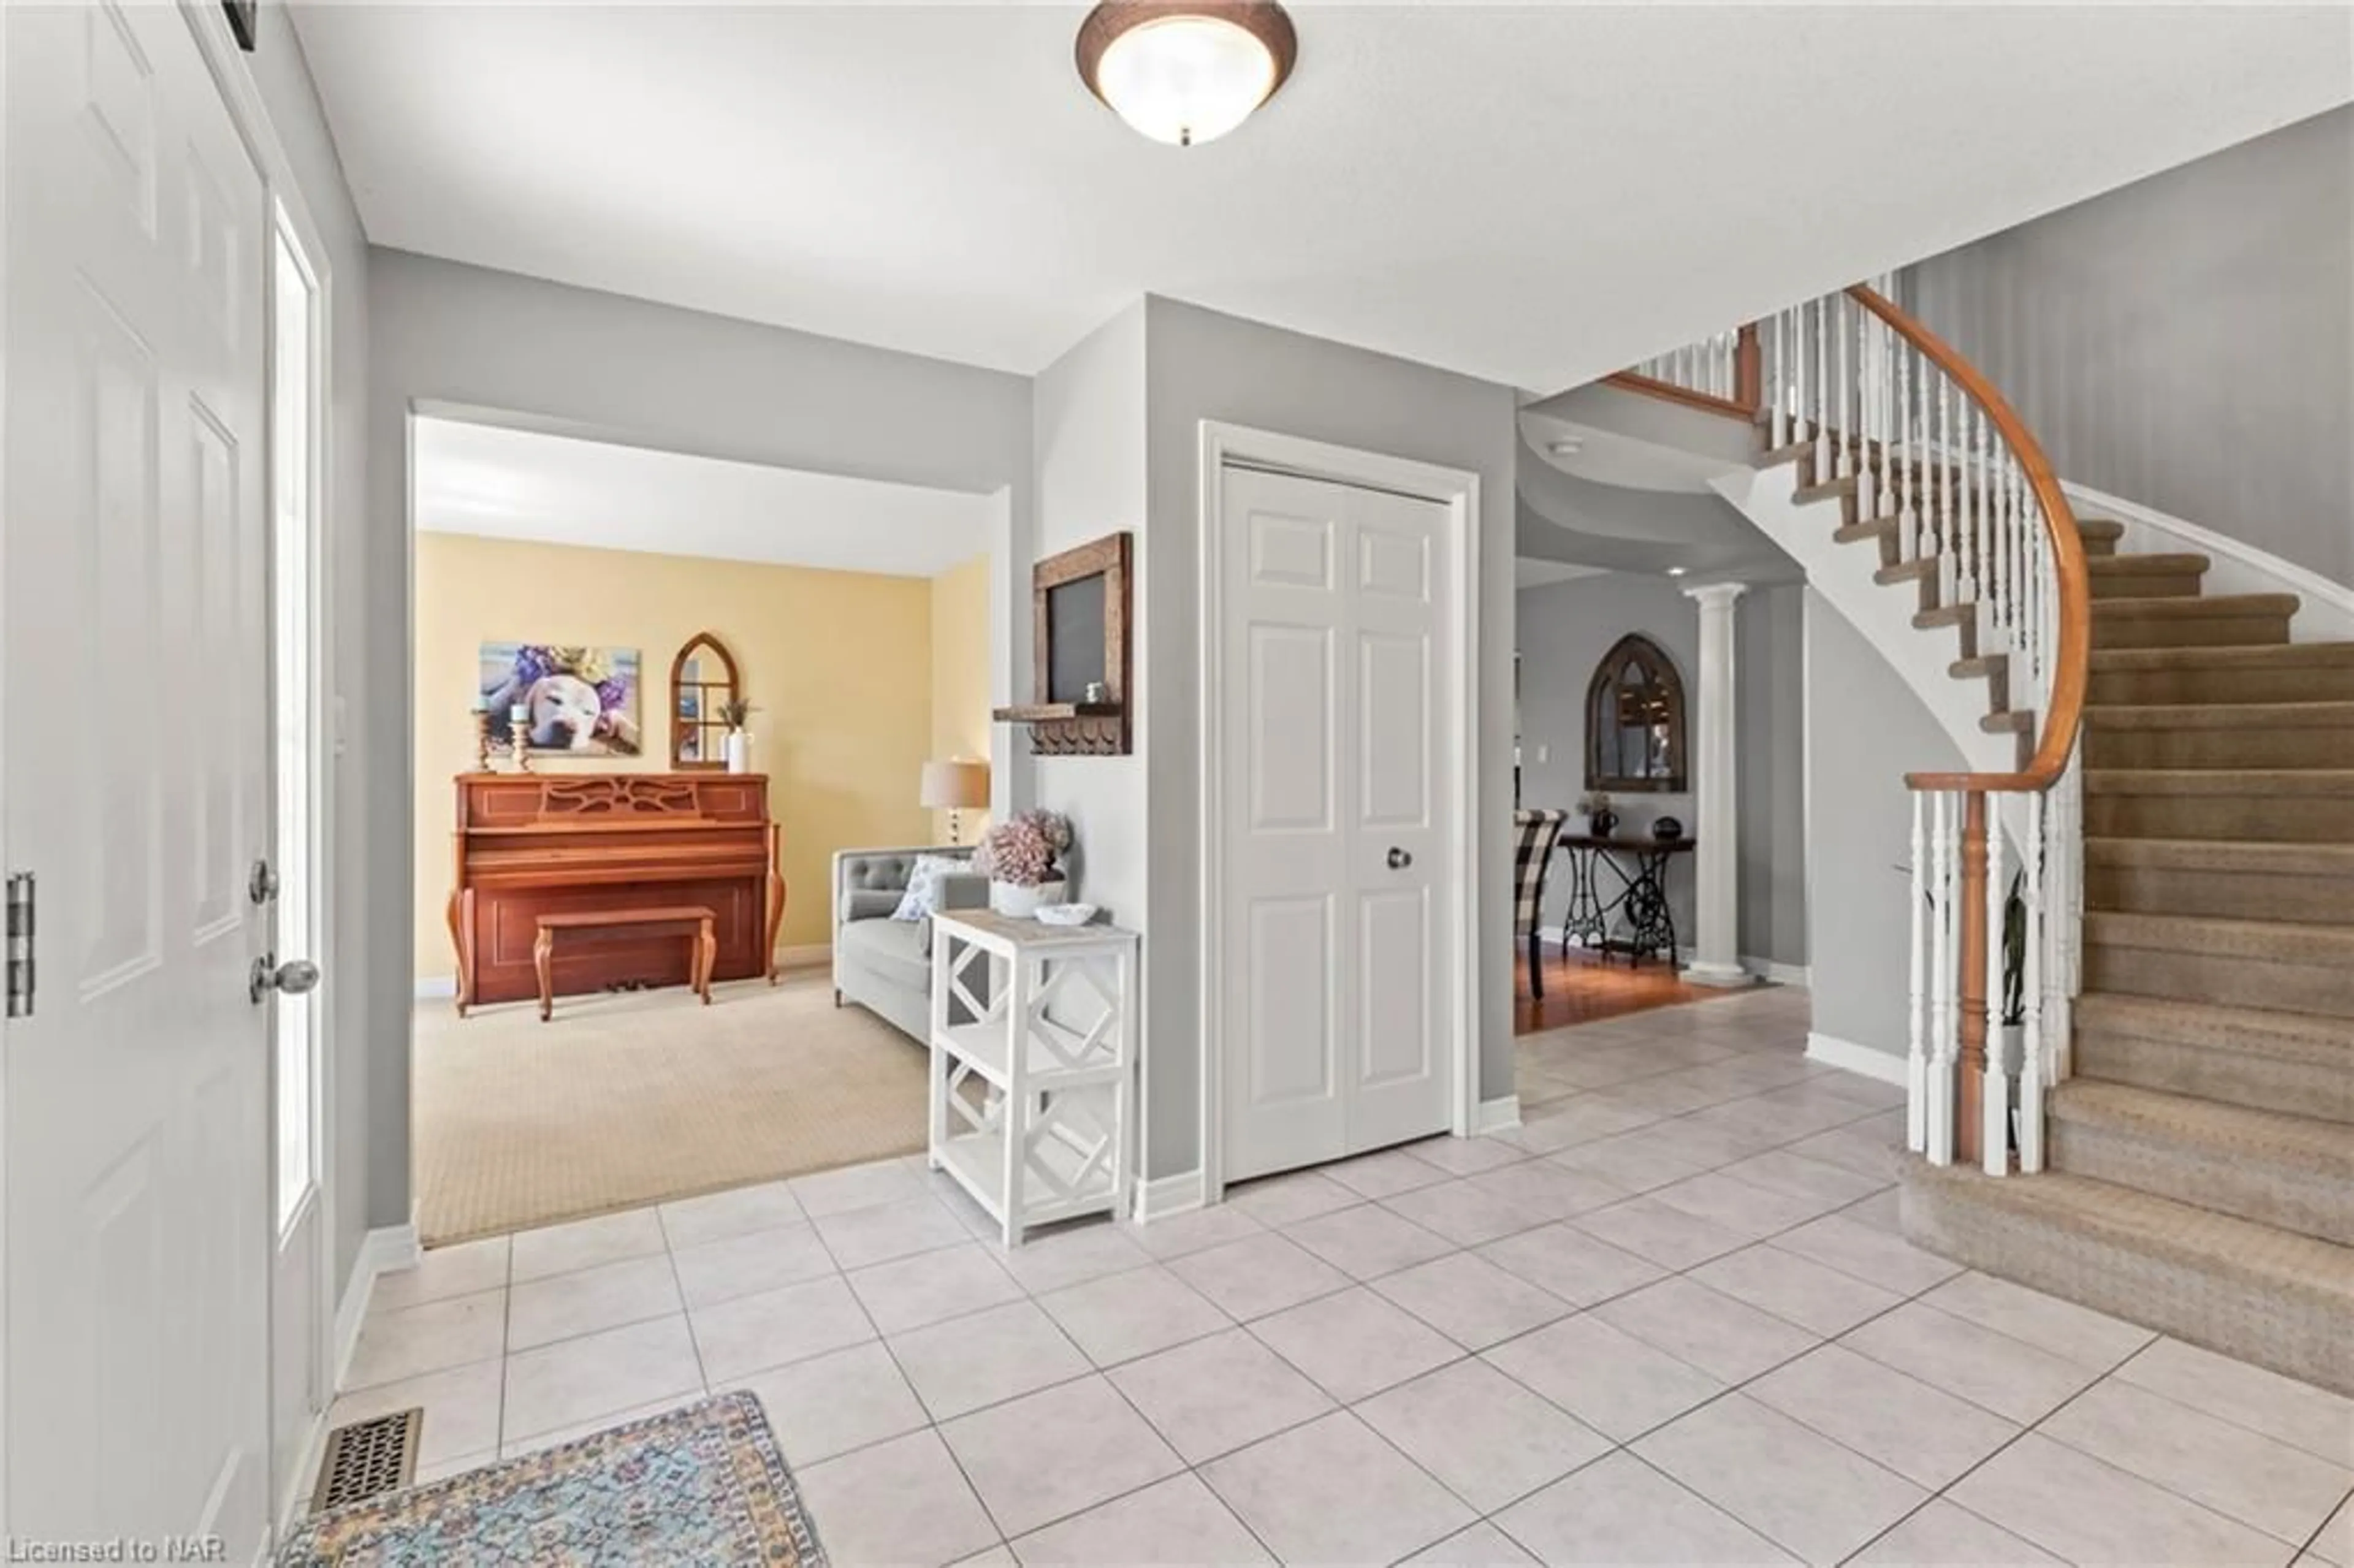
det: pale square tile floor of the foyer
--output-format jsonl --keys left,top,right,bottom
{"left": 332, "top": 991, "right": 2354, "bottom": 1568}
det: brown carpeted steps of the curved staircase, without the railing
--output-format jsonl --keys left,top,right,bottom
{"left": 1905, "top": 520, "right": 2354, "bottom": 1394}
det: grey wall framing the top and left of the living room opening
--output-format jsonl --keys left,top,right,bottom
{"left": 365, "top": 249, "right": 1034, "bottom": 1224}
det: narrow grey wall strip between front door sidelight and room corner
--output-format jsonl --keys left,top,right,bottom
{"left": 247, "top": 5, "right": 371, "bottom": 1290}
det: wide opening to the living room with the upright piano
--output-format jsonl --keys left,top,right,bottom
{"left": 409, "top": 417, "right": 1005, "bottom": 1246}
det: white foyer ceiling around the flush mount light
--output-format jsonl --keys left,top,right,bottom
{"left": 284, "top": 0, "right": 2354, "bottom": 391}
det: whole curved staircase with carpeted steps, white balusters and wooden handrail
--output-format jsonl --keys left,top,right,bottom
{"left": 1612, "top": 287, "right": 2354, "bottom": 1394}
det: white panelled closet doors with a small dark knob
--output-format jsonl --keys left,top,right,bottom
{"left": 1210, "top": 466, "right": 1462, "bottom": 1182}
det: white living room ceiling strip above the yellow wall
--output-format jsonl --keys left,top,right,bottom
{"left": 414, "top": 419, "right": 993, "bottom": 577}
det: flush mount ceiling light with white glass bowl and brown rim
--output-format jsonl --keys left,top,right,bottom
{"left": 1078, "top": 0, "right": 1300, "bottom": 146}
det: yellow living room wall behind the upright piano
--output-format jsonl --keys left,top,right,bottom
{"left": 419, "top": 532, "right": 932, "bottom": 980}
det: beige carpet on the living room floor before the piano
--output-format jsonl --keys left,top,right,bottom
{"left": 412, "top": 972, "right": 925, "bottom": 1246}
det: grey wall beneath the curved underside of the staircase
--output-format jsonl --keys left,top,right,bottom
{"left": 1805, "top": 591, "right": 1968, "bottom": 1057}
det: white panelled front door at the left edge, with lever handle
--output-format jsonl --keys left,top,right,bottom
{"left": 0, "top": 0, "right": 271, "bottom": 1563}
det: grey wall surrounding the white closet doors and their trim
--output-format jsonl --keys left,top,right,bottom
{"left": 1141, "top": 297, "right": 1518, "bottom": 1177}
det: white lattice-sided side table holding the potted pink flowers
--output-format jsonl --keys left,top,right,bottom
{"left": 930, "top": 909, "right": 1137, "bottom": 1248}
